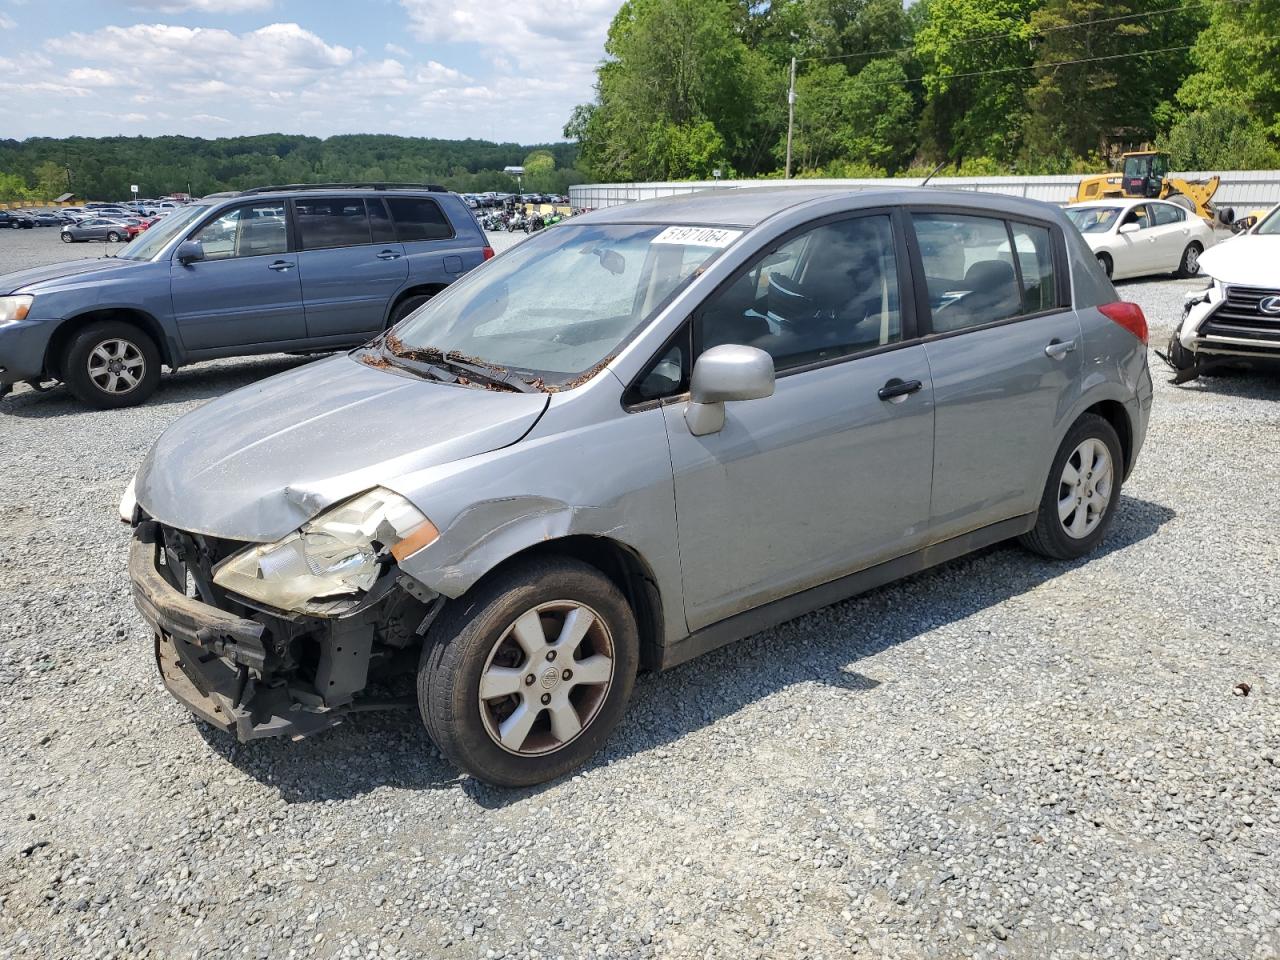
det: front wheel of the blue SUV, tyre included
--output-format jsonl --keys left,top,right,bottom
{"left": 61, "top": 320, "right": 160, "bottom": 410}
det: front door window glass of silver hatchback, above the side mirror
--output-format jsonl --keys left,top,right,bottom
{"left": 696, "top": 215, "right": 902, "bottom": 372}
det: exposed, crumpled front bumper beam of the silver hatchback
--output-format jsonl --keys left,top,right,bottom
{"left": 129, "top": 525, "right": 344, "bottom": 742}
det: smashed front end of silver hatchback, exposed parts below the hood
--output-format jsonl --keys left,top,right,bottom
{"left": 129, "top": 504, "right": 443, "bottom": 742}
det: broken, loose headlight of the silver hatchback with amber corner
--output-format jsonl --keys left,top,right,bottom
{"left": 214, "top": 488, "right": 439, "bottom": 613}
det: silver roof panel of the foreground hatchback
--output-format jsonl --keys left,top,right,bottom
{"left": 573, "top": 187, "right": 1056, "bottom": 227}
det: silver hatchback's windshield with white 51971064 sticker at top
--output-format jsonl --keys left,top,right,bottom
{"left": 387, "top": 224, "right": 742, "bottom": 387}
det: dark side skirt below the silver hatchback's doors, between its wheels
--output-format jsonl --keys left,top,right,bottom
{"left": 658, "top": 513, "right": 1036, "bottom": 669}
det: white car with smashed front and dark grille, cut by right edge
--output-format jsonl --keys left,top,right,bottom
{"left": 1165, "top": 206, "right": 1280, "bottom": 383}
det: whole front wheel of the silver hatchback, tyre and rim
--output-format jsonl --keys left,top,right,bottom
{"left": 417, "top": 558, "right": 640, "bottom": 787}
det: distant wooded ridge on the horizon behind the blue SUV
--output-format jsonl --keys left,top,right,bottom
{"left": 0, "top": 133, "right": 585, "bottom": 201}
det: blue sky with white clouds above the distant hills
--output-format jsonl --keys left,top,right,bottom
{"left": 0, "top": 0, "right": 621, "bottom": 143}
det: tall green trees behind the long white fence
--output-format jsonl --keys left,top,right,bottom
{"left": 564, "top": 0, "right": 1280, "bottom": 180}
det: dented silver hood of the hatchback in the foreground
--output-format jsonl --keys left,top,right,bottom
{"left": 134, "top": 356, "right": 549, "bottom": 541}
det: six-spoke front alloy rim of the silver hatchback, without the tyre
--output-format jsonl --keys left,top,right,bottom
{"left": 479, "top": 600, "right": 614, "bottom": 756}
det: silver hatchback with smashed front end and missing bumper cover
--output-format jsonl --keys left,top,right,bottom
{"left": 120, "top": 188, "right": 1152, "bottom": 786}
